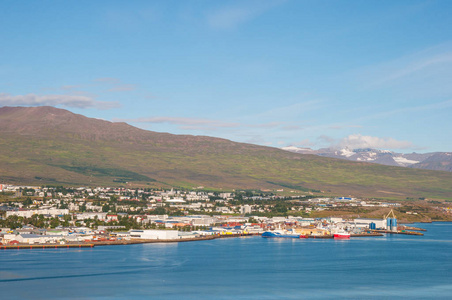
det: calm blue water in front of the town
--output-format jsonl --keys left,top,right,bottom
{"left": 0, "top": 223, "right": 452, "bottom": 299}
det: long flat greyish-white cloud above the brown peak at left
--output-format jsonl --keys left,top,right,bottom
{"left": 0, "top": 93, "right": 119, "bottom": 109}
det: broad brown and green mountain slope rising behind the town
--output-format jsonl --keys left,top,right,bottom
{"left": 0, "top": 107, "right": 452, "bottom": 199}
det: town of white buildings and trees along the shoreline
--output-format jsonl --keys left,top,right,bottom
{"left": 0, "top": 184, "right": 444, "bottom": 245}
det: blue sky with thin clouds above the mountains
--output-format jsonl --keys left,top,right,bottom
{"left": 0, "top": 0, "right": 452, "bottom": 153}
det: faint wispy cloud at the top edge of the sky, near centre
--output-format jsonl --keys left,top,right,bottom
{"left": 206, "top": 1, "right": 284, "bottom": 30}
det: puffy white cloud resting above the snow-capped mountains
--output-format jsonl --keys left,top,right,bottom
{"left": 337, "top": 134, "right": 413, "bottom": 149}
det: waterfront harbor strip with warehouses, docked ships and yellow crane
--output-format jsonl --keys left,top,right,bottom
{"left": 0, "top": 209, "right": 425, "bottom": 250}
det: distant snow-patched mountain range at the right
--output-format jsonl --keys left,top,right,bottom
{"left": 282, "top": 146, "right": 452, "bottom": 172}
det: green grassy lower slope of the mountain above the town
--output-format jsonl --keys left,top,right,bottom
{"left": 0, "top": 134, "right": 452, "bottom": 199}
